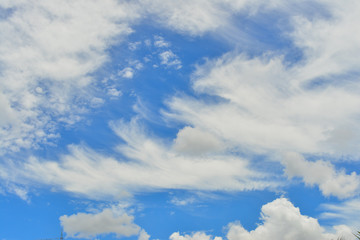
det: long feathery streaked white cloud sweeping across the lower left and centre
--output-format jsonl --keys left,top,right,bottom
{"left": 0, "top": 120, "right": 277, "bottom": 199}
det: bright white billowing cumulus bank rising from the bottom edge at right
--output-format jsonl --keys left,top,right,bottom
{"left": 170, "top": 198, "right": 354, "bottom": 240}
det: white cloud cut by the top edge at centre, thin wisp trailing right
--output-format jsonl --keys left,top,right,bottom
{"left": 140, "top": 0, "right": 308, "bottom": 37}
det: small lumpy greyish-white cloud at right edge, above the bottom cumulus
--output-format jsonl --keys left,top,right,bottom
{"left": 282, "top": 153, "right": 360, "bottom": 198}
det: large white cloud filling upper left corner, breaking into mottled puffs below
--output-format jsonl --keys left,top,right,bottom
{"left": 0, "top": 0, "right": 138, "bottom": 153}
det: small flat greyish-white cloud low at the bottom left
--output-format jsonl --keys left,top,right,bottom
{"left": 60, "top": 209, "right": 141, "bottom": 239}
